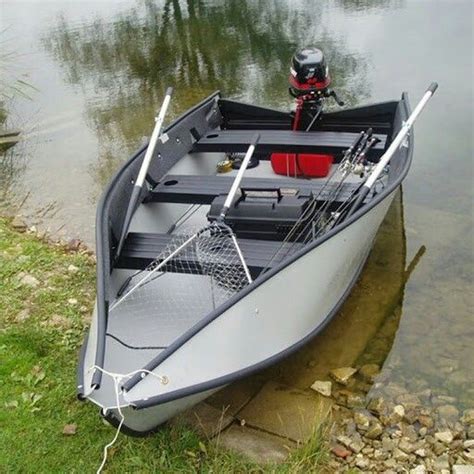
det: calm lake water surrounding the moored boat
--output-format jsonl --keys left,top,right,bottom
{"left": 0, "top": 0, "right": 474, "bottom": 406}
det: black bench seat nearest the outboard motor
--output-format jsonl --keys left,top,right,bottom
{"left": 193, "top": 130, "right": 387, "bottom": 161}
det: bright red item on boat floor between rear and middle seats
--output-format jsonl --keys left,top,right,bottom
{"left": 271, "top": 153, "right": 334, "bottom": 178}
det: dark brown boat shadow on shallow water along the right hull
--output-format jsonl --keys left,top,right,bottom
{"left": 210, "top": 191, "right": 425, "bottom": 435}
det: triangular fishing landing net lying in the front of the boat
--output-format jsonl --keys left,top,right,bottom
{"left": 110, "top": 223, "right": 251, "bottom": 345}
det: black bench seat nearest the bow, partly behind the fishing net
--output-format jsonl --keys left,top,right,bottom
{"left": 116, "top": 232, "right": 303, "bottom": 278}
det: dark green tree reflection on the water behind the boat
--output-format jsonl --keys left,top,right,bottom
{"left": 42, "top": 0, "right": 370, "bottom": 193}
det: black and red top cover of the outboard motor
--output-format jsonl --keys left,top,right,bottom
{"left": 289, "top": 47, "right": 331, "bottom": 96}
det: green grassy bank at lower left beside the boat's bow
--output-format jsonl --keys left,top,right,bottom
{"left": 0, "top": 218, "right": 327, "bottom": 473}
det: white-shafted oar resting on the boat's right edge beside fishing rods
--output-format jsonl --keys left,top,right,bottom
{"left": 345, "top": 82, "right": 438, "bottom": 219}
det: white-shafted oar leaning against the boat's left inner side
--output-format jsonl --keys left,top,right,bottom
{"left": 115, "top": 87, "right": 173, "bottom": 257}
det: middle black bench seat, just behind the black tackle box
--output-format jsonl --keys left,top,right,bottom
{"left": 146, "top": 175, "right": 359, "bottom": 204}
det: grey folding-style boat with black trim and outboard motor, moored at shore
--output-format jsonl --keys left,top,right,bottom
{"left": 77, "top": 48, "right": 437, "bottom": 435}
